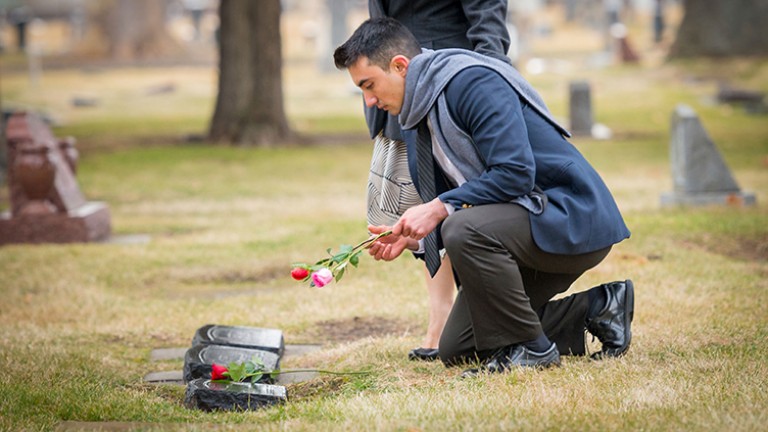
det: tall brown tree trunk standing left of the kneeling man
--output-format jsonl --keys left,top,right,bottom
{"left": 209, "top": 0, "right": 291, "bottom": 146}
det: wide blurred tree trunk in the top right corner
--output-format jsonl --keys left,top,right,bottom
{"left": 669, "top": 0, "right": 768, "bottom": 58}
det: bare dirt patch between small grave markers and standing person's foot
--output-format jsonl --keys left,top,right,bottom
{"left": 310, "top": 316, "right": 416, "bottom": 343}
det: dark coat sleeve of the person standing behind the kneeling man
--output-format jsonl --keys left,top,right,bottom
{"left": 461, "top": 0, "right": 510, "bottom": 63}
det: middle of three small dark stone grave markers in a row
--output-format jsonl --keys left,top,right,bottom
{"left": 184, "top": 344, "right": 280, "bottom": 382}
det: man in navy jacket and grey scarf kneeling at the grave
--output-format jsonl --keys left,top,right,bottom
{"left": 334, "top": 18, "right": 634, "bottom": 376}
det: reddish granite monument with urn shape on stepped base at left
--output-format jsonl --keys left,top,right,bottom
{"left": 0, "top": 112, "right": 111, "bottom": 245}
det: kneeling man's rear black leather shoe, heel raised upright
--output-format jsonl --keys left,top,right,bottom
{"left": 587, "top": 279, "right": 635, "bottom": 359}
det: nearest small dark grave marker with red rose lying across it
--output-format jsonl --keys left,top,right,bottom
{"left": 184, "top": 378, "right": 287, "bottom": 411}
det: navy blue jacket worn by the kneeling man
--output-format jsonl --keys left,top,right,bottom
{"left": 401, "top": 62, "right": 630, "bottom": 255}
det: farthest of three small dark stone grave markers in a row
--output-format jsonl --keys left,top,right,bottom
{"left": 192, "top": 324, "right": 285, "bottom": 356}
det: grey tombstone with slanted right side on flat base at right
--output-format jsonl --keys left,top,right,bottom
{"left": 661, "top": 105, "right": 756, "bottom": 205}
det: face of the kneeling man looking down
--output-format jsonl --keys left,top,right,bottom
{"left": 347, "top": 56, "right": 408, "bottom": 115}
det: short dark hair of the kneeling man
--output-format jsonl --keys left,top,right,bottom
{"left": 333, "top": 18, "right": 421, "bottom": 70}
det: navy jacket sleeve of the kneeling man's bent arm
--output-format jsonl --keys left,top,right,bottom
{"left": 439, "top": 67, "right": 536, "bottom": 210}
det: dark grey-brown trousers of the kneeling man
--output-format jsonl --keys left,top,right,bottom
{"left": 439, "top": 204, "right": 611, "bottom": 365}
